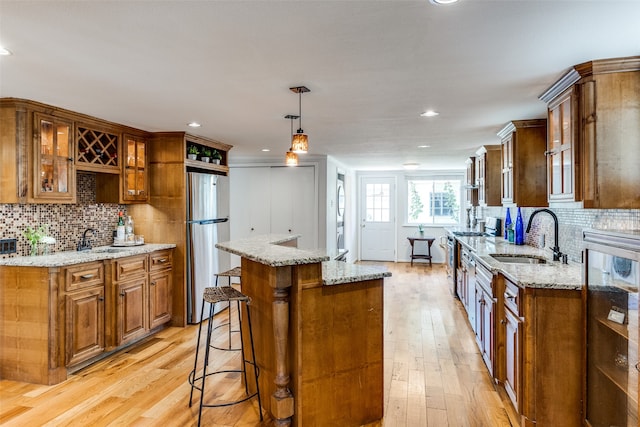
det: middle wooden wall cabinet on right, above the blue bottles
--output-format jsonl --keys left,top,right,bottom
{"left": 498, "top": 120, "right": 547, "bottom": 207}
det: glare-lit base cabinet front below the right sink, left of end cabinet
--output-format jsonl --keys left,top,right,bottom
{"left": 475, "top": 262, "right": 497, "bottom": 376}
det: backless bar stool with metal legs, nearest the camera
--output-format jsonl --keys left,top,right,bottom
{"left": 189, "top": 286, "right": 263, "bottom": 426}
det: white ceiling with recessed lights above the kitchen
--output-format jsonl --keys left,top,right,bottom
{"left": 0, "top": 0, "right": 640, "bottom": 169}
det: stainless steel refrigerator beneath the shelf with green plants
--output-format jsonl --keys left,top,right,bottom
{"left": 186, "top": 172, "right": 230, "bottom": 323}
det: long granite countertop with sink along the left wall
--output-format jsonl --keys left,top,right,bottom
{"left": 0, "top": 243, "right": 176, "bottom": 267}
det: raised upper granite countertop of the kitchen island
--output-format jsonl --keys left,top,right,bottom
{"left": 216, "top": 234, "right": 329, "bottom": 267}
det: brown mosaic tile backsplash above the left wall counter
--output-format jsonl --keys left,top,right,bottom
{"left": 0, "top": 173, "right": 127, "bottom": 258}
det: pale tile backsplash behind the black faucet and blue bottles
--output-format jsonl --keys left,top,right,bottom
{"left": 478, "top": 207, "right": 640, "bottom": 262}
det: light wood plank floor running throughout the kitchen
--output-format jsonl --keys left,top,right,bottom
{"left": 0, "top": 263, "right": 511, "bottom": 427}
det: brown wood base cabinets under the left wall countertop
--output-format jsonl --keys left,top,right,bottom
{"left": 0, "top": 249, "right": 173, "bottom": 384}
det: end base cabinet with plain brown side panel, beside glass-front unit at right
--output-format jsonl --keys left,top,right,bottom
{"left": 497, "top": 275, "right": 583, "bottom": 427}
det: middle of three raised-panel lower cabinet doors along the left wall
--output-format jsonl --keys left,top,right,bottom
{"left": 116, "top": 278, "right": 148, "bottom": 345}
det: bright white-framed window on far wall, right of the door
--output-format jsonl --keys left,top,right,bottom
{"left": 407, "top": 177, "right": 462, "bottom": 225}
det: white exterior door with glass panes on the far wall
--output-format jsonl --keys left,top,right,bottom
{"left": 360, "top": 177, "right": 396, "bottom": 261}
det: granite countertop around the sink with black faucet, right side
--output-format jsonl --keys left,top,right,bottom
{"left": 448, "top": 229, "right": 583, "bottom": 290}
